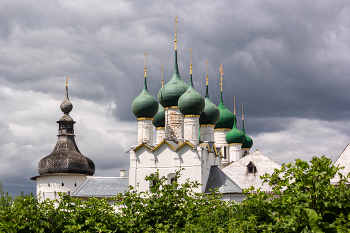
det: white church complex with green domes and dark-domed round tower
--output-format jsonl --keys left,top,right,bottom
{"left": 31, "top": 21, "right": 350, "bottom": 201}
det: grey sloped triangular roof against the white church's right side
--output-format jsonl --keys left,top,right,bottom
{"left": 204, "top": 165, "right": 242, "bottom": 193}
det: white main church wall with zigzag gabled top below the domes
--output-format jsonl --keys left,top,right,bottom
{"left": 129, "top": 144, "right": 221, "bottom": 192}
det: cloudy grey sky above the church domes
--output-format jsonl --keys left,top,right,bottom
{"left": 0, "top": 0, "right": 350, "bottom": 195}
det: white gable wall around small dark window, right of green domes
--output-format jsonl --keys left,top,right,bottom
{"left": 222, "top": 149, "right": 281, "bottom": 192}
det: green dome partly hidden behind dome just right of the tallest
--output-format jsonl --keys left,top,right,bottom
{"left": 199, "top": 85, "right": 220, "bottom": 125}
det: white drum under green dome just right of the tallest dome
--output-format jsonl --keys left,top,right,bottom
{"left": 184, "top": 115, "right": 199, "bottom": 145}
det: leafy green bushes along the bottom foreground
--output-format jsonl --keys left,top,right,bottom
{"left": 0, "top": 156, "right": 350, "bottom": 232}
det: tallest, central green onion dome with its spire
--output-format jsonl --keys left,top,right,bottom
{"left": 158, "top": 50, "right": 188, "bottom": 108}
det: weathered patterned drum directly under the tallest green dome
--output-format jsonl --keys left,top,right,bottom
{"left": 164, "top": 106, "right": 184, "bottom": 141}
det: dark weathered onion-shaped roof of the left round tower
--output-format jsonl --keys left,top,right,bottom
{"left": 38, "top": 87, "right": 95, "bottom": 176}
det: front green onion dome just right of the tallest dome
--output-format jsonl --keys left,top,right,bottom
{"left": 178, "top": 71, "right": 205, "bottom": 116}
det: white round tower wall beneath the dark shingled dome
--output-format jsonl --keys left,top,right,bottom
{"left": 36, "top": 174, "right": 86, "bottom": 200}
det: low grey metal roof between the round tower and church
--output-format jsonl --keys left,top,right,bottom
{"left": 72, "top": 176, "right": 129, "bottom": 197}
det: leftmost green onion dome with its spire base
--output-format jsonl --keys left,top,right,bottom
{"left": 131, "top": 77, "right": 158, "bottom": 118}
